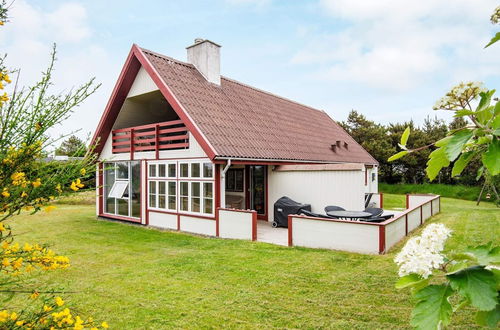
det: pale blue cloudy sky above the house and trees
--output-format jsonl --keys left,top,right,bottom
{"left": 0, "top": 0, "right": 500, "bottom": 143}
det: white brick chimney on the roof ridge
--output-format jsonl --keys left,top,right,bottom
{"left": 186, "top": 38, "right": 221, "bottom": 85}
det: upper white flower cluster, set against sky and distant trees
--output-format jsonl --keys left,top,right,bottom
{"left": 432, "top": 81, "right": 487, "bottom": 110}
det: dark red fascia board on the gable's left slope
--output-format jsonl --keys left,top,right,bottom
{"left": 91, "top": 47, "right": 141, "bottom": 154}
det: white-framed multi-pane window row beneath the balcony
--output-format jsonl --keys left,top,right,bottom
{"left": 148, "top": 161, "right": 215, "bottom": 216}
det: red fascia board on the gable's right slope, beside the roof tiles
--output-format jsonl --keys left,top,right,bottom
{"left": 132, "top": 44, "right": 216, "bottom": 159}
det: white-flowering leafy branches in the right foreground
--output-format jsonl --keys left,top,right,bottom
{"left": 389, "top": 7, "right": 500, "bottom": 329}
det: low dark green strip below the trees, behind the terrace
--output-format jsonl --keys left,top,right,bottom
{"left": 379, "top": 183, "right": 494, "bottom": 201}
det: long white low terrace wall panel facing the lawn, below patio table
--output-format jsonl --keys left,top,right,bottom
{"left": 292, "top": 217, "right": 379, "bottom": 254}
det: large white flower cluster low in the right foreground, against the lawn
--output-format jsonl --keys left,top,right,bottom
{"left": 394, "top": 223, "right": 451, "bottom": 278}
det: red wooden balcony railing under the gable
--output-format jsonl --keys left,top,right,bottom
{"left": 113, "top": 120, "right": 189, "bottom": 159}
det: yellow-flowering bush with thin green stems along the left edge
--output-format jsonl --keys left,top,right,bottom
{"left": 0, "top": 0, "right": 108, "bottom": 329}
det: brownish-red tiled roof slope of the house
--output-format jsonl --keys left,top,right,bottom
{"left": 131, "top": 45, "right": 377, "bottom": 164}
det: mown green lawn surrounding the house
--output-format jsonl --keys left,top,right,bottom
{"left": 4, "top": 195, "right": 500, "bottom": 329}
